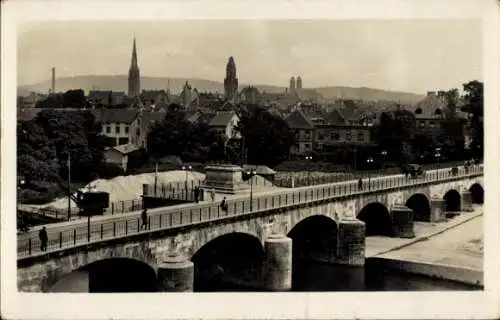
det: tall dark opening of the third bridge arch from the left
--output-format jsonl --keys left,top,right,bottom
{"left": 288, "top": 215, "right": 338, "bottom": 291}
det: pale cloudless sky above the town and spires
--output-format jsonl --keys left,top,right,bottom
{"left": 18, "top": 19, "right": 483, "bottom": 93}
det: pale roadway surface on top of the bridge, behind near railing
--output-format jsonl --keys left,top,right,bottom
{"left": 18, "top": 168, "right": 480, "bottom": 256}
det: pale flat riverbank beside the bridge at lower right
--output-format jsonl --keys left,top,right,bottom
{"left": 371, "top": 208, "right": 484, "bottom": 287}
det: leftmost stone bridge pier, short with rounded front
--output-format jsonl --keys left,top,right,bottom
{"left": 158, "top": 256, "right": 194, "bottom": 292}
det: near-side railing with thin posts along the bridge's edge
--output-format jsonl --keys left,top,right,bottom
{"left": 18, "top": 165, "right": 483, "bottom": 258}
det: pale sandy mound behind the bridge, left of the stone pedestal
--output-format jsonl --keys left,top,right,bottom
{"left": 41, "top": 170, "right": 205, "bottom": 209}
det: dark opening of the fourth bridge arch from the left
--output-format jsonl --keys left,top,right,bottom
{"left": 357, "top": 202, "right": 393, "bottom": 237}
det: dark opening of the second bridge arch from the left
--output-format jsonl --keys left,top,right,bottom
{"left": 191, "top": 232, "right": 264, "bottom": 292}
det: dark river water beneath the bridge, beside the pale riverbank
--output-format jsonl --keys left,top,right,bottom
{"left": 195, "top": 259, "right": 482, "bottom": 292}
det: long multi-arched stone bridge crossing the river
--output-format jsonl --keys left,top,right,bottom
{"left": 18, "top": 167, "right": 484, "bottom": 292}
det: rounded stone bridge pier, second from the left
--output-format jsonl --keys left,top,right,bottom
{"left": 262, "top": 234, "right": 292, "bottom": 291}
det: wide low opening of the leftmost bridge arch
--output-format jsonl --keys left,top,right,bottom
{"left": 47, "top": 258, "right": 158, "bottom": 293}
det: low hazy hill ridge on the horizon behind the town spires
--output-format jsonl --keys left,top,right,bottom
{"left": 18, "top": 75, "right": 425, "bottom": 103}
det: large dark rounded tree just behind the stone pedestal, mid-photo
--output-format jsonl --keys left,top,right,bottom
{"left": 238, "top": 106, "right": 295, "bottom": 166}
